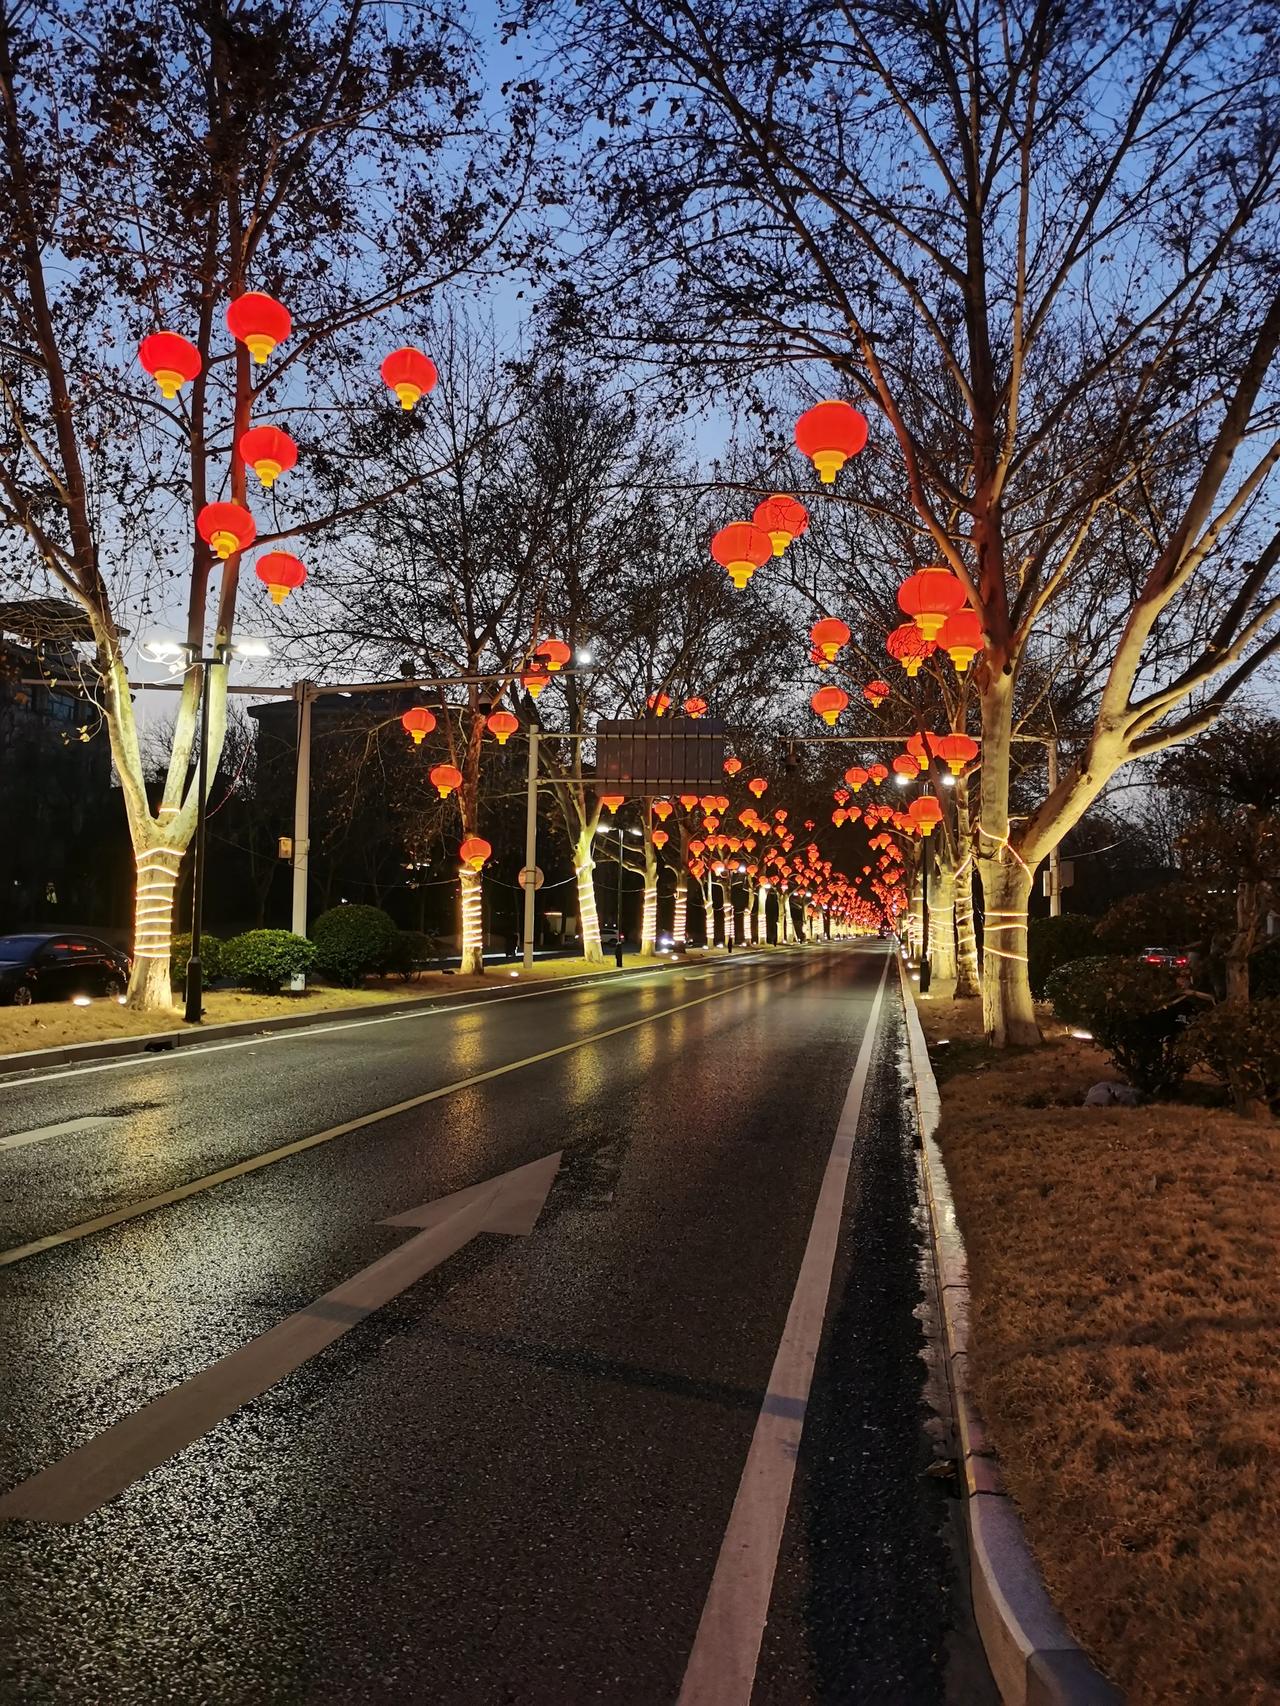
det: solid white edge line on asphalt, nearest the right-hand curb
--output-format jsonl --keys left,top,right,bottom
{"left": 678, "top": 960, "right": 889, "bottom": 1706}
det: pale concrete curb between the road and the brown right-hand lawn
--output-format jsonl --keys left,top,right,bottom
{"left": 898, "top": 955, "right": 1123, "bottom": 1706}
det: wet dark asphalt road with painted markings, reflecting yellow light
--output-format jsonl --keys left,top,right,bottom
{"left": 0, "top": 943, "right": 988, "bottom": 1706}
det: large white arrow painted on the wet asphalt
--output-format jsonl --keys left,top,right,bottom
{"left": 0, "top": 1152, "right": 560, "bottom": 1522}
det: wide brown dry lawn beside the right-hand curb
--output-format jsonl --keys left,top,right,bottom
{"left": 920, "top": 998, "right": 1280, "bottom": 1706}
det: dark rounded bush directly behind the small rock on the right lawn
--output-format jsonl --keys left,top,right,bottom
{"left": 1044, "top": 954, "right": 1201, "bottom": 1095}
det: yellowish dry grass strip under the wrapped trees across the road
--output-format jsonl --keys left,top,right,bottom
{"left": 0, "top": 950, "right": 696, "bottom": 1054}
